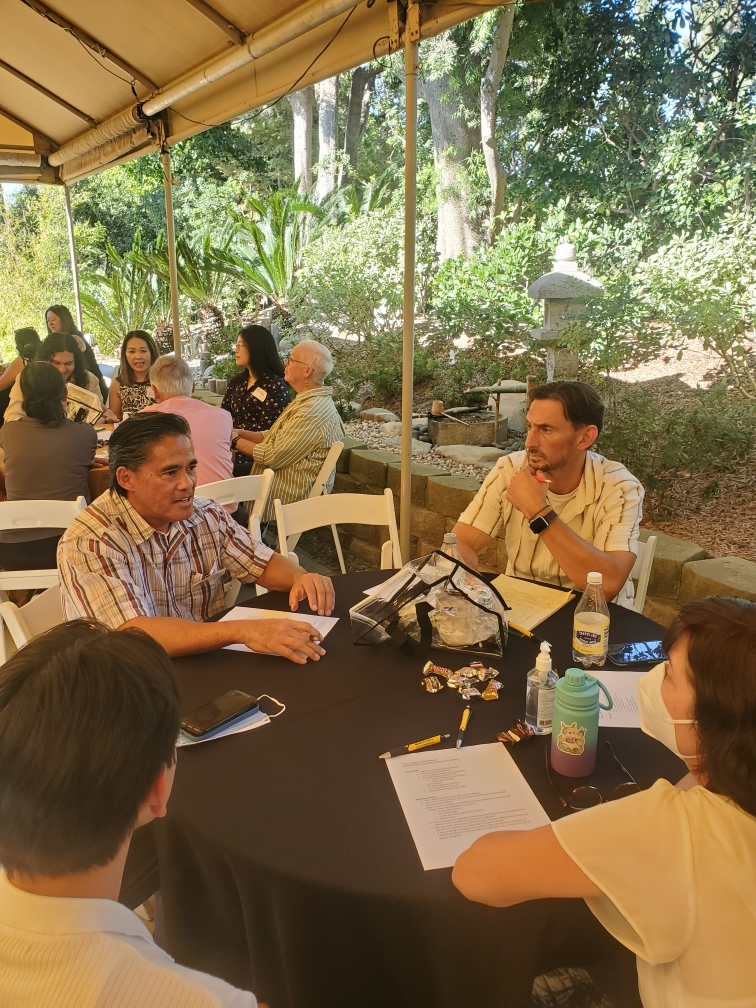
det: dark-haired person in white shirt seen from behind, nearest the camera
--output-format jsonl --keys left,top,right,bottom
{"left": 0, "top": 620, "right": 264, "bottom": 1008}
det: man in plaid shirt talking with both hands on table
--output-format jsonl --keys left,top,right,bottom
{"left": 57, "top": 412, "right": 334, "bottom": 664}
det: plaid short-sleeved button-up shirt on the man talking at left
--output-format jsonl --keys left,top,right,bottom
{"left": 57, "top": 491, "right": 273, "bottom": 629}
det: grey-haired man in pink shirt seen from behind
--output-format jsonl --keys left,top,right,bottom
{"left": 142, "top": 355, "right": 248, "bottom": 526}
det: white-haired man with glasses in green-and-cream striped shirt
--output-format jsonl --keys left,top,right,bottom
{"left": 231, "top": 340, "right": 344, "bottom": 521}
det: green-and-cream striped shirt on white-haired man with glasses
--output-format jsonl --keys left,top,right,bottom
{"left": 252, "top": 388, "right": 344, "bottom": 521}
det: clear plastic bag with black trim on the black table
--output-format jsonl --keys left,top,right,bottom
{"left": 349, "top": 549, "right": 509, "bottom": 657}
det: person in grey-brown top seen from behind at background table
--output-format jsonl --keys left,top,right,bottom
{"left": 0, "top": 361, "right": 97, "bottom": 571}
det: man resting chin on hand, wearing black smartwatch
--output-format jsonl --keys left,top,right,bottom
{"left": 454, "top": 381, "right": 643, "bottom": 608}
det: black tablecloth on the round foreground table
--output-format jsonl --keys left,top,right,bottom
{"left": 155, "top": 572, "right": 684, "bottom": 1008}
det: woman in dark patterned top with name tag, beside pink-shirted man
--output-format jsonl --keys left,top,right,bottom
{"left": 221, "top": 326, "right": 289, "bottom": 476}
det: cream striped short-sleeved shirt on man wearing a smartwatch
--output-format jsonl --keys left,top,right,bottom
{"left": 460, "top": 452, "right": 643, "bottom": 603}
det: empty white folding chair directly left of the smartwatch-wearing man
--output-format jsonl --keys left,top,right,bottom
{"left": 273, "top": 489, "right": 401, "bottom": 574}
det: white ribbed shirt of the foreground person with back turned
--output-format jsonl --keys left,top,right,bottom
{"left": 0, "top": 872, "right": 257, "bottom": 1008}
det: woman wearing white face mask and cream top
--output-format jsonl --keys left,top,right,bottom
{"left": 453, "top": 598, "right": 756, "bottom": 1008}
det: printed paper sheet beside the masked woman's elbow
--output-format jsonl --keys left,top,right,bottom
{"left": 386, "top": 742, "right": 550, "bottom": 872}
